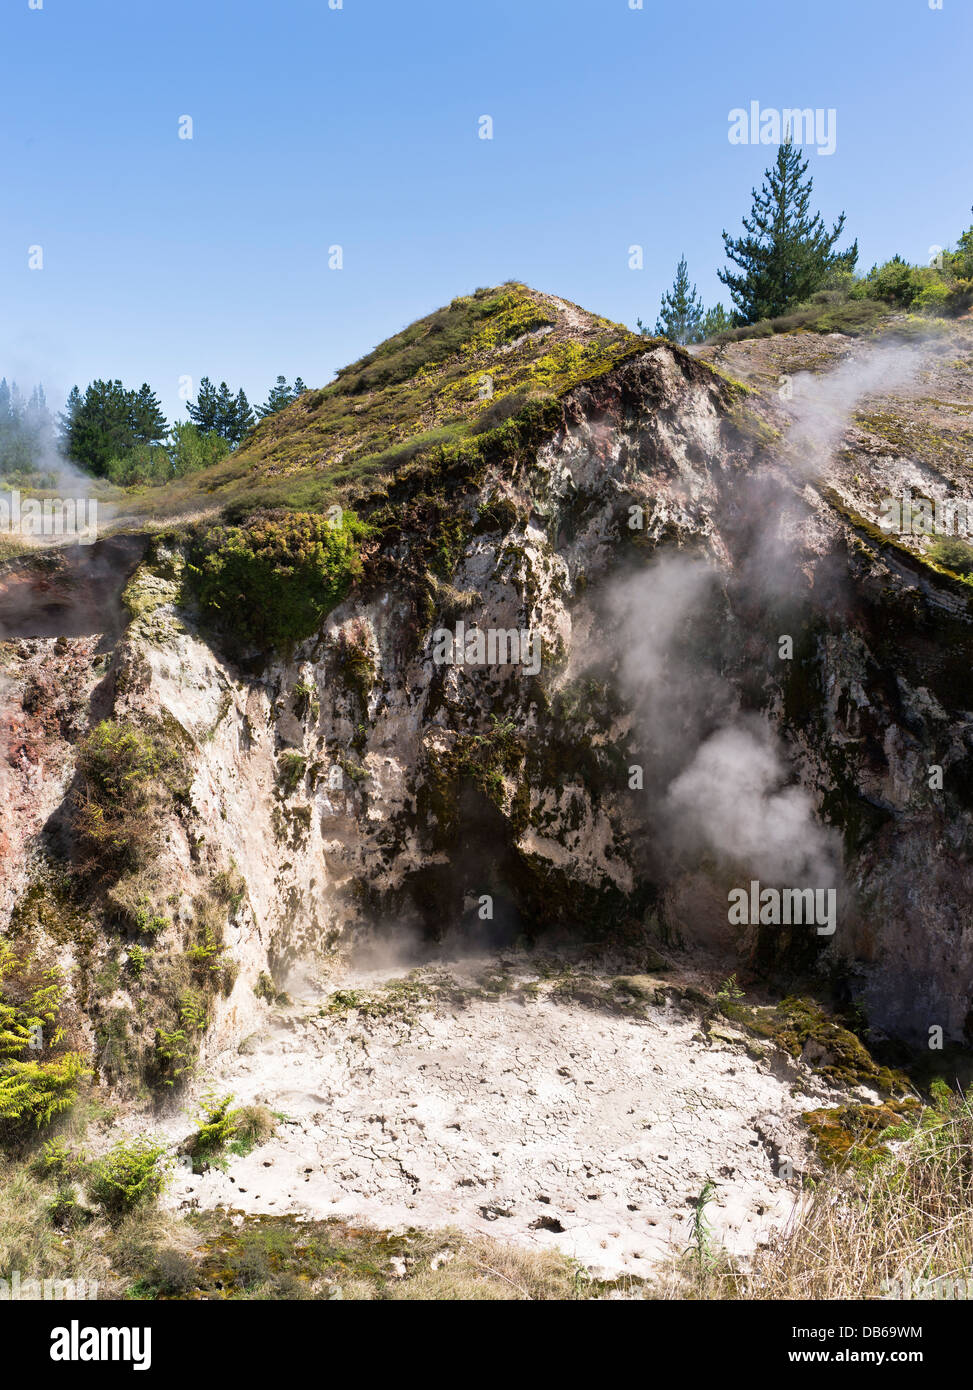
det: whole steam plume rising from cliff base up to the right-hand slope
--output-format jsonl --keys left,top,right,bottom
{"left": 609, "top": 348, "right": 920, "bottom": 887}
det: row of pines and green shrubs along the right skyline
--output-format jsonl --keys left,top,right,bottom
{"left": 637, "top": 132, "right": 973, "bottom": 343}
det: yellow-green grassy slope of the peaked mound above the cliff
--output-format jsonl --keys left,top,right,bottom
{"left": 122, "top": 282, "right": 646, "bottom": 517}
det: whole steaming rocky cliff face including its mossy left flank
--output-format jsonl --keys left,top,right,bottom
{"left": 0, "top": 290, "right": 973, "bottom": 1106}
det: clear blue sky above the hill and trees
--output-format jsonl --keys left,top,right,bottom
{"left": 0, "top": 0, "right": 973, "bottom": 416}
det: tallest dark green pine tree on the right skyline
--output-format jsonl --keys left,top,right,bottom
{"left": 717, "top": 131, "right": 858, "bottom": 324}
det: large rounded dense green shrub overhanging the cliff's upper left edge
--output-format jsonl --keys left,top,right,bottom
{"left": 183, "top": 512, "right": 367, "bottom": 649}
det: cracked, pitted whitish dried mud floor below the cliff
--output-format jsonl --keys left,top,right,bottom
{"left": 155, "top": 956, "right": 821, "bottom": 1276}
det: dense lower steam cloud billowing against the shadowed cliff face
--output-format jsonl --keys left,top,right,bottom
{"left": 612, "top": 555, "right": 838, "bottom": 887}
